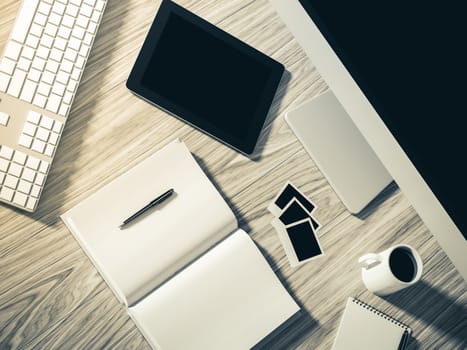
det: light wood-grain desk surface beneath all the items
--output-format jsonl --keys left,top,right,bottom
{"left": 0, "top": 0, "right": 467, "bottom": 349}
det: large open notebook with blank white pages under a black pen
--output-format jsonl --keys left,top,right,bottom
{"left": 62, "top": 141, "right": 299, "bottom": 350}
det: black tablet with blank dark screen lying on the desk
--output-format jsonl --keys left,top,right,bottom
{"left": 127, "top": 0, "right": 284, "bottom": 154}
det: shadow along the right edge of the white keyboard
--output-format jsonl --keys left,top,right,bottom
{"left": 13, "top": 0, "right": 129, "bottom": 225}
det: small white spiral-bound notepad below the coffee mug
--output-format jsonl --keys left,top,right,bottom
{"left": 333, "top": 298, "right": 412, "bottom": 350}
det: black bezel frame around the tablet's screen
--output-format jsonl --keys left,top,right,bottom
{"left": 126, "top": 0, "right": 284, "bottom": 155}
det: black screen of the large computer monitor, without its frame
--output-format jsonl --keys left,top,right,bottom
{"left": 300, "top": 0, "right": 467, "bottom": 238}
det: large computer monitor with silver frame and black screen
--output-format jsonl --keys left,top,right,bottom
{"left": 270, "top": 0, "right": 467, "bottom": 280}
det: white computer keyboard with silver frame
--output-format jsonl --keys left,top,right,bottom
{"left": 0, "top": 0, "right": 106, "bottom": 212}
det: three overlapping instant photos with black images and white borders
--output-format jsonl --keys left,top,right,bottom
{"left": 268, "top": 182, "right": 323, "bottom": 266}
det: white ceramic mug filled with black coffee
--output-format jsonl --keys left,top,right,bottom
{"left": 358, "top": 244, "right": 423, "bottom": 296}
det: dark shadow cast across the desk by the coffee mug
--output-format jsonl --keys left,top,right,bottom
{"left": 383, "top": 281, "right": 467, "bottom": 349}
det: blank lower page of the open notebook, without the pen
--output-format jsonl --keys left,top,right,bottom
{"left": 129, "top": 230, "right": 299, "bottom": 350}
